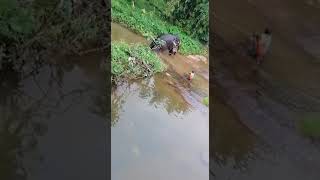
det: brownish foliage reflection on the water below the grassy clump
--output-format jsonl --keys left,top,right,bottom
{"left": 112, "top": 74, "right": 190, "bottom": 122}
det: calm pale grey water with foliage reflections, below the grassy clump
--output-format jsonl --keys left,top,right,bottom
{"left": 111, "top": 75, "right": 209, "bottom": 180}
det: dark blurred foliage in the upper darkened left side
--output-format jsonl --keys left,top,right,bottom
{"left": 0, "top": 0, "right": 108, "bottom": 70}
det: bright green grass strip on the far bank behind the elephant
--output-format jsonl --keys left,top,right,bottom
{"left": 111, "top": 0, "right": 206, "bottom": 55}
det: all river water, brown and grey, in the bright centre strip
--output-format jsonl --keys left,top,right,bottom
{"left": 111, "top": 23, "right": 209, "bottom": 180}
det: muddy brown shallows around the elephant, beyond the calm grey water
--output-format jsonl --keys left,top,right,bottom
{"left": 111, "top": 23, "right": 209, "bottom": 111}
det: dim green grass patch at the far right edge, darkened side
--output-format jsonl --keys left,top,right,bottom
{"left": 298, "top": 113, "right": 320, "bottom": 138}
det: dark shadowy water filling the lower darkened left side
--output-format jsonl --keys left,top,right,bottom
{"left": 0, "top": 51, "right": 106, "bottom": 180}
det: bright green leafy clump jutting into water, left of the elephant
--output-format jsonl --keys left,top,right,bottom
{"left": 111, "top": 42, "right": 166, "bottom": 81}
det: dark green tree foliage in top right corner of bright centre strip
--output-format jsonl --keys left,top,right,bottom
{"left": 170, "top": 0, "right": 209, "bottom": 42}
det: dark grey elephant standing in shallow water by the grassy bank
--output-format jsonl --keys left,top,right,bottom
{"left": 150, "top": 34, "right": 180, "bottom": 55}
